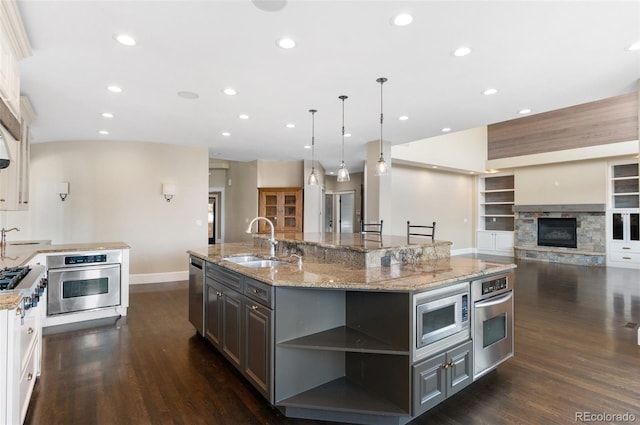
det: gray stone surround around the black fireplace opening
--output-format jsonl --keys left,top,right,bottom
{"left": 513, "top": 204, "right": 607, "bottom": 266}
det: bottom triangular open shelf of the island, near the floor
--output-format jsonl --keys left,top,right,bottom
{"left": 277, "top": 376, "right": 409, "bottom": 416}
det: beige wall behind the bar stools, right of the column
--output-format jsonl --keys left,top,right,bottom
{"left": 384, "top": 164, "right": 476, "bottom": 250}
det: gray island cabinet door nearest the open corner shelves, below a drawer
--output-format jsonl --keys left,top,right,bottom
{"left": 244, "top": 299, "right": 272, "bottom": 401}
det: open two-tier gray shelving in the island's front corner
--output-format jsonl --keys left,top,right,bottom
{"left": 275, "top": 288, "right": 412, "bottom": 423}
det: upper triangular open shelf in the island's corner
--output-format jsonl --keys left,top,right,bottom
{"left": 278, "top": 326, "right": 409, "bottom": 355}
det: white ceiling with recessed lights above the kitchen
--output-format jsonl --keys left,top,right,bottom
{"left": 19, "top": 0, "right": 640, "bottom": 171}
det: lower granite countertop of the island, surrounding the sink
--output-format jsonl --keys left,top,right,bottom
{"left": 188, "top": 239, "right": 516, "bottom": 292}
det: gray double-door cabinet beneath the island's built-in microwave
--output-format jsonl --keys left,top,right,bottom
{"left": 413, "top": 341, "right": 473, "bottom": 416}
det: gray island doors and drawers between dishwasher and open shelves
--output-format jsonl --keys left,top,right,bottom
{"left": 204, "top": 263, "right": 274, "bottom": 403}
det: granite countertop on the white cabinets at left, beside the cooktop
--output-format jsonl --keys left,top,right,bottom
{"left": 0, "top": 240, "right": 130, "bottom": 310}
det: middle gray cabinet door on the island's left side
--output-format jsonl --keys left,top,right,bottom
{"left": 221, "top": 287, "right": 243, "bottom": 370}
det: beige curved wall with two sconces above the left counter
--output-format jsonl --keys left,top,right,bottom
{"left": 2, "top": 141, "right": 208, "bottom": 274}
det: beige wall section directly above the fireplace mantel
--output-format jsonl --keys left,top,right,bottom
{"left": 514, "top": 159, "right": 607, "bottom": 205}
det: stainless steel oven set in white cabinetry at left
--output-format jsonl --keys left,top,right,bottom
{"left": 47, "top": 251, "right": 122, "bottom": 316}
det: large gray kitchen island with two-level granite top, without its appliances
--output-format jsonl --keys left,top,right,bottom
{"left": 189, "top": 234, "right": 515, "bottom": 424}
